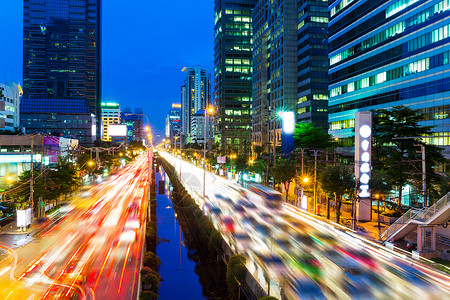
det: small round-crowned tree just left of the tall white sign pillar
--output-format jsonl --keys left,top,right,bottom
{"left": 318, "top": 166, "right": 355, "bottom": 223}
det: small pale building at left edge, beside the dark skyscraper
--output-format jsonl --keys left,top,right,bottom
{"left": 0, "top": 82, "right": 22, "bottom": 132}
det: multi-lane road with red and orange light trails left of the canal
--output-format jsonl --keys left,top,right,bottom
{"left": 0, "top": 155, "right": 149, "bottom": 300}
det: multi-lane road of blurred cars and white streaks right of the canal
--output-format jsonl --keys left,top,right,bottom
{"left": 161, "top": 152, "right": 450, "bottom": 300}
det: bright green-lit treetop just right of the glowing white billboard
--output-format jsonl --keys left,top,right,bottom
{"left": 294, "top": 122, "right": 336, "bottom": 149}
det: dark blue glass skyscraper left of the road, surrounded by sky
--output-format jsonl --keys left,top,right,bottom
{"left": 21, "top": 0, "right": 101, "bottom": 143}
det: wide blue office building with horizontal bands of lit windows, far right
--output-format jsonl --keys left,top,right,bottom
{"left": 328, "top": 0, "right": 450, "bottom": 156}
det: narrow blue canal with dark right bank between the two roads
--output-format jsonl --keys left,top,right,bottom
{"left": 155, "top": 168, "right": 226, "bottom": 300}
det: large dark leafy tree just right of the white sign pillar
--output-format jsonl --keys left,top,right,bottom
{"left": 373, "top": 106, "right": 445, "bottom": 205}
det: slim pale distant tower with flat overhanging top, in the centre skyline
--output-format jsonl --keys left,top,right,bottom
{"left": 181, "top": 66, "right": 211, "bottom": 144}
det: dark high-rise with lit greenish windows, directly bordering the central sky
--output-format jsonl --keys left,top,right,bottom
{"left": 213, "top": 0, "right": 257, "bottom": 154}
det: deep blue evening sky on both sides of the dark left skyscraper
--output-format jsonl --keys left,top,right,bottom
{"left": 0, "top": 0, "right": 214, "bottom": 142}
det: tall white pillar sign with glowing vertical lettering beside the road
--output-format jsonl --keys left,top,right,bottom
{"left": 355, "top": 111, "right": 372, "bottom": 221}
